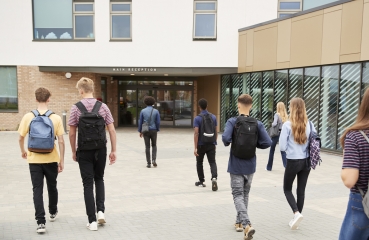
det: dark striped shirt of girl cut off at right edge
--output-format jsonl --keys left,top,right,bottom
{"left": 342, "top": 130, "right": 369, "bottom": 193}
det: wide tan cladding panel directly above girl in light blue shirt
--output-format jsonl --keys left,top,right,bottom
{"left": 290, "top": 11, "right": 323, "bottom": 67}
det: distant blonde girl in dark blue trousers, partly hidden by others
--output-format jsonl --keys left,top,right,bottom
{"left": 266, "top": 102, "right": 288, "bottom": 171}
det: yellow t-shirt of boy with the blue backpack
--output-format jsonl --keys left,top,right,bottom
{"left": 18, "top": 111, "right": 64, "bottom": 163}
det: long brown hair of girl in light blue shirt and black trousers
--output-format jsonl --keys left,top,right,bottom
{"left": 290, "top": 98, "right": 308, "bottom": 144}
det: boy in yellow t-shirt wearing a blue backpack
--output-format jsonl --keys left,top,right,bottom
{"left": 18, "top": 88, "right": 65, "bottom": 233}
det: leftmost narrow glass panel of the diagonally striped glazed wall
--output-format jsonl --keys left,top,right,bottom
{"left": 220, "top": 75, "right": 231, "bottom": 130}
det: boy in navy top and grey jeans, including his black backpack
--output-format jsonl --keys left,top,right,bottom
{"left": 222, "top": 94, "right": 272, "bottom": 240}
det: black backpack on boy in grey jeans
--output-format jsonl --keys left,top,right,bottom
{"left": 231, "top": 115, "right": 259, "bottom": 159}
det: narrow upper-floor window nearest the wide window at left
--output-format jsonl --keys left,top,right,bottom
{"left": 110, "top": 1, "right": 132, "bottom": 40}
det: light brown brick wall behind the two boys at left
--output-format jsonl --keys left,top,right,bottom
{"left": 0, "top": 66, "right": 112, "bottom": 130}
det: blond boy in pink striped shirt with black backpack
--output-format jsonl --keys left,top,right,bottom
{"left": 68, "top": 78, "right": 116, "bottom": 231}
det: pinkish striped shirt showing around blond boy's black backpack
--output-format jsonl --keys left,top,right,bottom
{"left": 68, "top": 98, "right": 114, "bottom": 127}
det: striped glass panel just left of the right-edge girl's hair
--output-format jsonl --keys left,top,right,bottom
{"left": 337, "top": 63, "right": 361, "bottom": 149}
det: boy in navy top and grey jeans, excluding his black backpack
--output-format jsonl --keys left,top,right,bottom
{"left": 222, "top": 94, "right": 272, "bottom": 240}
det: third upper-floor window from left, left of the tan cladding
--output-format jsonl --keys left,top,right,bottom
{"left": 193, "top": 1, "right": 217, "bottom": 39}
